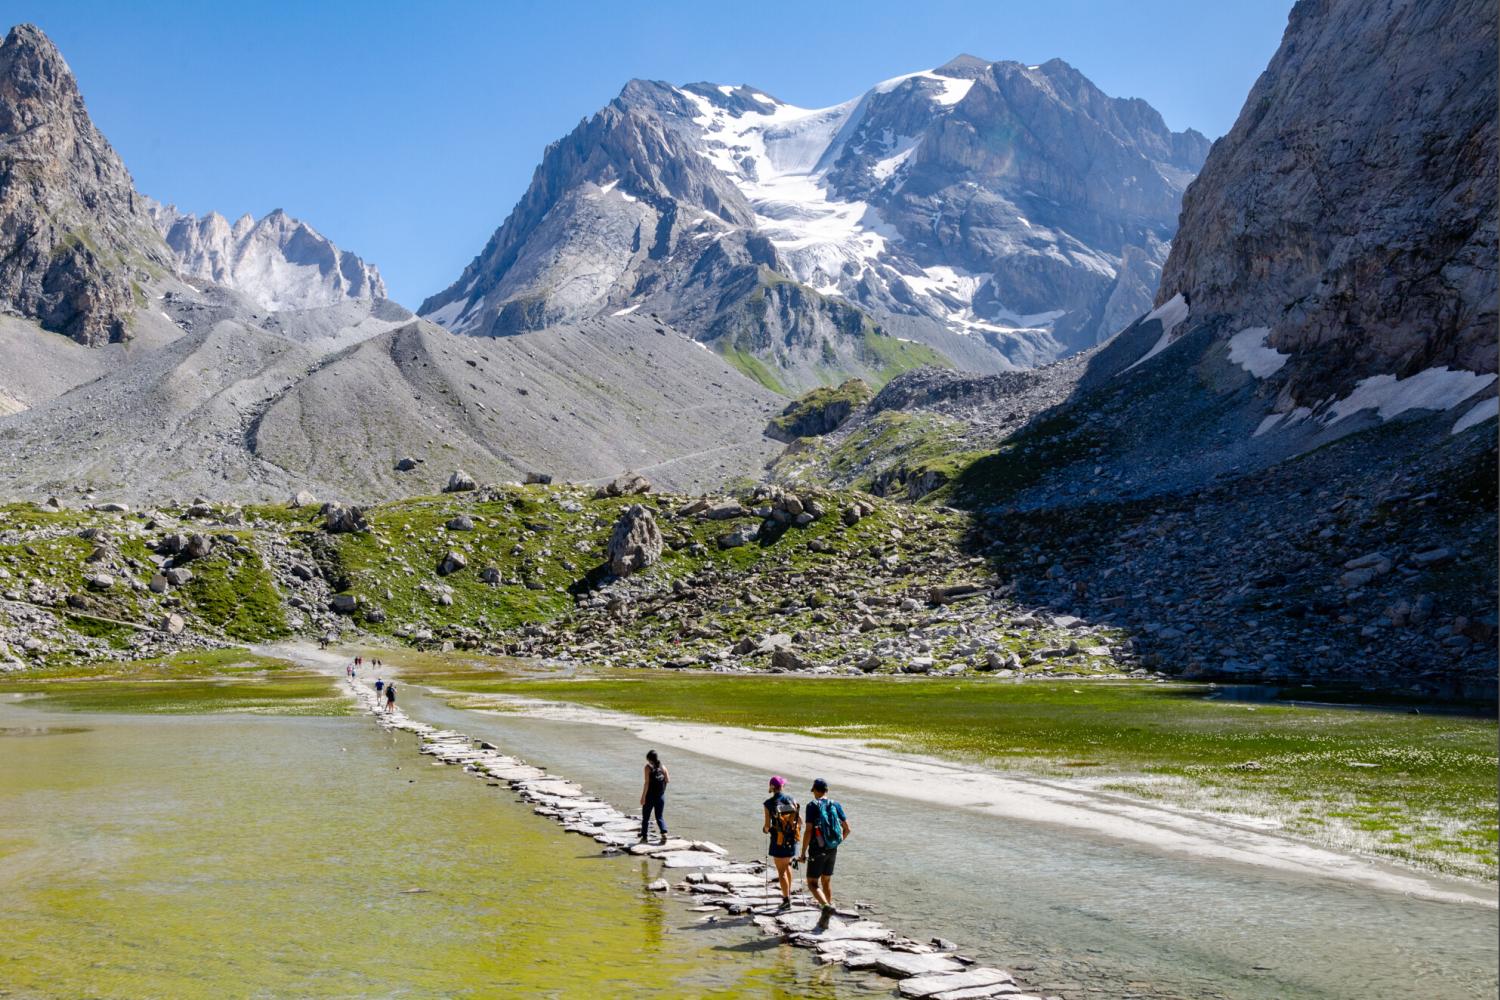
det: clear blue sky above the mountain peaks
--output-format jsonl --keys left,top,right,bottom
{"left": 0, "top": 0, "right": 1292, "bottom": 307}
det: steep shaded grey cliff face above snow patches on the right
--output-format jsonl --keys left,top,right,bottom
{"left": 1157, "top": 0, "right": 1500, "bottom": 405}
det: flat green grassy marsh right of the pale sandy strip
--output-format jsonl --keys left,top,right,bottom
{"left": 447, "top": 673, "right": 1497, "bottom": 880}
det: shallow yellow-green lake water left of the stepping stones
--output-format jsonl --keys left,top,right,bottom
{"left": 0, "top": 705, "right": 860, "bottom": 1000}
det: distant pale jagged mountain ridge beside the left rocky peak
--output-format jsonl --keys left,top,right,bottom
{"left": 152, "top": 205, "right": 386, "bottom": 310}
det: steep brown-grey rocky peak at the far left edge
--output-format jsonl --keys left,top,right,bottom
{"left": 0, "top": 24, "right": 171, "bottom": 346}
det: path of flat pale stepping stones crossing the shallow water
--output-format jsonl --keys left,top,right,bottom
{"left": 350, "top": 681, "right": 1040, "bottom": 1000}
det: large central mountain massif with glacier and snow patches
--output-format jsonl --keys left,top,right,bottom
{"left": 422, "top": 55, "right": 1209, "bottom": 382}
